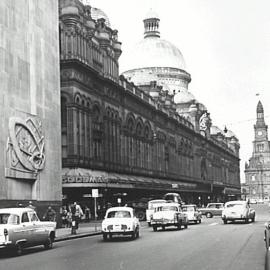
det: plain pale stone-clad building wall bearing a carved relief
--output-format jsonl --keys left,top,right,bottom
{"left": 0, "top": 0, "right": 62, "bottom": 215}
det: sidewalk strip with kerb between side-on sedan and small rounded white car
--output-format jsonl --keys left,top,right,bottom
{"left": 55, "top": 221, "right": 101, "bottom": 242}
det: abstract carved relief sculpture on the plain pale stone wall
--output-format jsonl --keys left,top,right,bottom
{"left": 5, "top": 117, "right": 45, "bottom": 179}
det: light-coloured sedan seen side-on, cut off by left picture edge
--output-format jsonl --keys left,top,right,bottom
{"left": 0, "top": 208, "right": 56, "bottom": 255}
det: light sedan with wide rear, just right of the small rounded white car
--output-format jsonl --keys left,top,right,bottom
{"left": 151, "top": 203, "right": 188, "bottom": 231}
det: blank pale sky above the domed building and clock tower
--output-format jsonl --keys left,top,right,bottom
{"left": 87, "top": 0, "right": 270, "bottom": 182}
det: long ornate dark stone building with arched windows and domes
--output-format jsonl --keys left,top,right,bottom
{"left": 59, "top": 0, "right": 240, "bottom": 217}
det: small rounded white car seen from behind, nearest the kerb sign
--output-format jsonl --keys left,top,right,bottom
{"left": 102, "top": 206, "right": 140, "bottom": 241}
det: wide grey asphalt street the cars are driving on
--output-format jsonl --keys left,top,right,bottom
{"left": 0, "top": 205, "right": 269, "bottom": 270}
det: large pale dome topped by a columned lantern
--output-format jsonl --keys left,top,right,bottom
{"left": 120, "top": 10, "right": 191, "bottom": 94}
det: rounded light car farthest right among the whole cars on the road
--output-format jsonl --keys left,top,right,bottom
{"left": 221, "top": 201, "right": 255, "bottom": 224}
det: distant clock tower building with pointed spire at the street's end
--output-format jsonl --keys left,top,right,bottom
{"left": 243, "top": 101, "right": 270, "bottom": 200}
